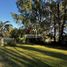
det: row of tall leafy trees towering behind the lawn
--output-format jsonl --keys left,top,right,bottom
{"left": 12, "top": 0, "right": 67, "bottom": 41}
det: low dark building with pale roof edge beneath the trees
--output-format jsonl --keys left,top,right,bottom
{"left": 24, "top": 34, "right": 42, "bottom": 44}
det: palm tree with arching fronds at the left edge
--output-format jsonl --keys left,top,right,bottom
{"left": 0, "top": 21, "right": 12, "bottom": 46}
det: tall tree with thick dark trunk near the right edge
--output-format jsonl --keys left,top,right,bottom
{"left": 56, "top": 0, "right": 67, "bottom": 42}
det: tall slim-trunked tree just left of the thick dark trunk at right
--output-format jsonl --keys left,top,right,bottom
{"left": 49, "top": 0, "right": 58, "bottom": 42}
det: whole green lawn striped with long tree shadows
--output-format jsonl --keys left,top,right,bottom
{"left": 0, "top": 45, "right": 67, "bottom": 67}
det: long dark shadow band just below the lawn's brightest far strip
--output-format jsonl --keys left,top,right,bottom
{"left": 16, "top": 46, "right": 67, "bottom": 60}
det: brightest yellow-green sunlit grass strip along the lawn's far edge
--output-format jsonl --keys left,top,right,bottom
{"left": 16, "top": 45, "right": 67, "bottom": 55}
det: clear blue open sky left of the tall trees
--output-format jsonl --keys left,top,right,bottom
{"left": 0, "top": 0, "right": 20, "bottom": 27}
